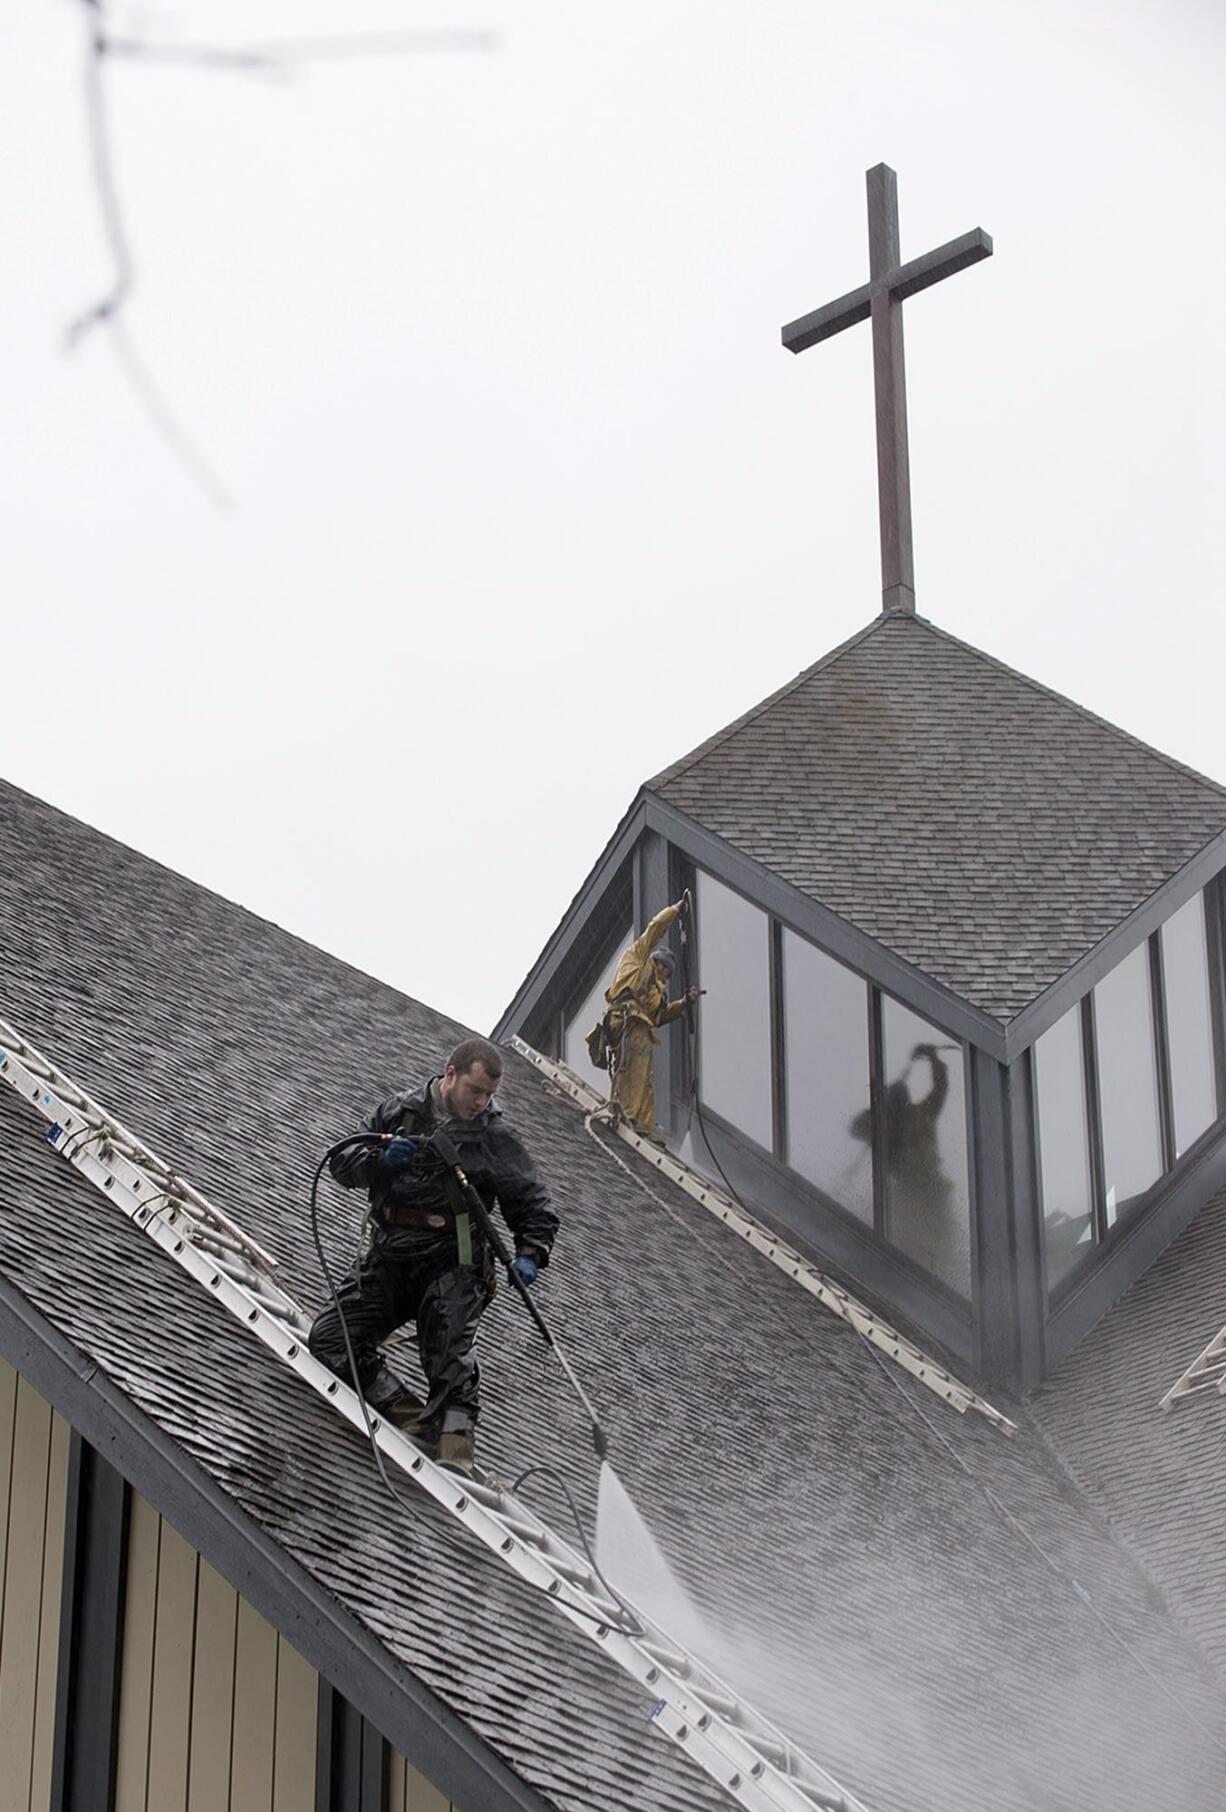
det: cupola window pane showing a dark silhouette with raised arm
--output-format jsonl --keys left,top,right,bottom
{"left": 882, "top": 995, "right": 971, "bottom": 1296}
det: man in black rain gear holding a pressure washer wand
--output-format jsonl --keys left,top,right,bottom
{"left": 308, "top": 1038, "right": 558, "bottom": 1471}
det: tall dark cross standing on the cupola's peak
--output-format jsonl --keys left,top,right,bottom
{"left": 782, "top": 163, "right": 992, "bottom": 611}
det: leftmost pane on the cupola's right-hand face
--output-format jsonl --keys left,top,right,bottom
{"left": 1034, "top": 1006, "right": 1094, "bottom": 1285}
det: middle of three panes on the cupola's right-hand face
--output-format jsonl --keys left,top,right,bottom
{"left": 1094, "top": 944, "right": 1163, "bottom": 1227}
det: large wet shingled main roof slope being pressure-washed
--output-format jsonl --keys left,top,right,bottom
{"left": 0, "top": 788, "right": 1226, "bottom": 1812}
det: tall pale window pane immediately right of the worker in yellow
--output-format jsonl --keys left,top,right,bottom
{"left": 695, "top": 870, "right": 773, "bottom": 1151}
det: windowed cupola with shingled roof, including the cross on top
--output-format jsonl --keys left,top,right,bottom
{"left": 498, "top": 167, "right": 1226, "bottom": 1392}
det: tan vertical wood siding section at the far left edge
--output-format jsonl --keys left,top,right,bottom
{"left": 0, "top": 1359, "right": 71, "bottom": 1812}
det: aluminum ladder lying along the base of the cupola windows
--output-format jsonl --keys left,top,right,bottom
{"left": 511, "top": 1035, "right": 1018, "bottom": 1435}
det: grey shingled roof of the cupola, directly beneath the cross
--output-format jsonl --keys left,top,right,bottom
{"left": 648, "top": 614, "right": 1226, "bottom": 1024}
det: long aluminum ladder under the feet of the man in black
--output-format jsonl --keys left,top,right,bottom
{"left": 0, "top": 1020, "right": 867, "bottom": 1812}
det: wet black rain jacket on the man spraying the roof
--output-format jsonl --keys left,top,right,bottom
{"left": 330, "top": 1084, "right": 558, "bottom": 1267}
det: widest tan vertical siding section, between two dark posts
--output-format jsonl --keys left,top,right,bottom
{"left": 116, "top": 1495, "right": 319, "bottom": 1812}
